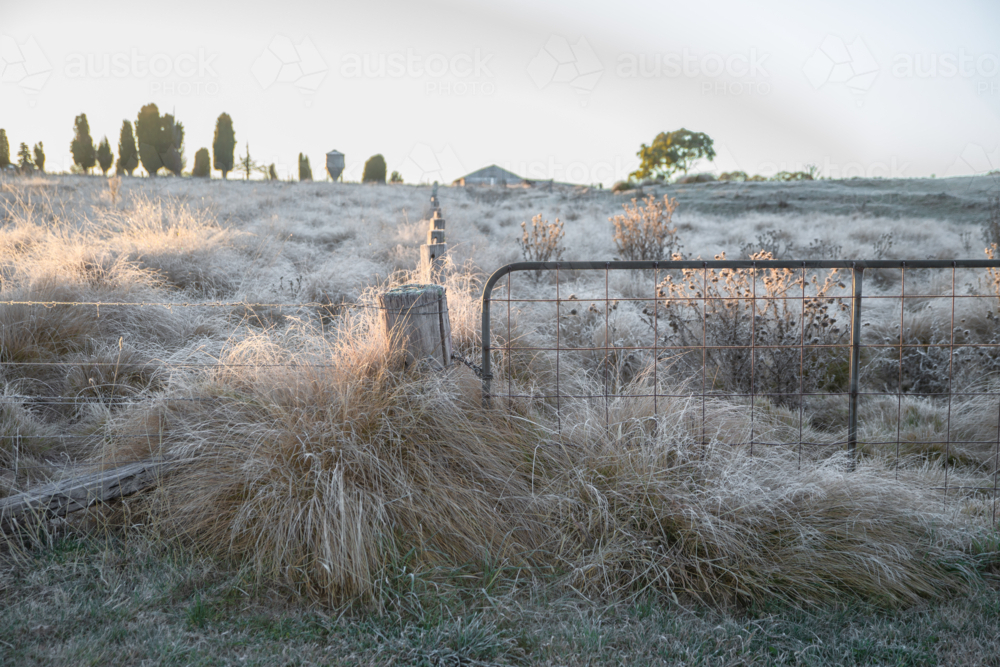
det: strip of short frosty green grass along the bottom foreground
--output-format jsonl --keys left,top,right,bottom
{"left": 0, "top": 536, "right": 1000, "bottom": 665}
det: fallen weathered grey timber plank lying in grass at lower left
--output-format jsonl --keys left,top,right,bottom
{"left": 0, "top": 460, "right": 166, "bottom": 530}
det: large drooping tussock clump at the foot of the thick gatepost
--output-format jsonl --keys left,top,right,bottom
{"left": 104, "top": 311, "right": 556, "bottom": 602}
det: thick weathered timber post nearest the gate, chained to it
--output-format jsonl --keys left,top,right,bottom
{"left": 378, "top": 284, "right": 451, "bottom": 368}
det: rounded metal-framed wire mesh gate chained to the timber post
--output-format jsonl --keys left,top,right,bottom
{"left": 481, "top": 260, "right": 1000, "bottom": 521}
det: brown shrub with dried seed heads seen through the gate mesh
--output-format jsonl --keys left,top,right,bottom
{"left": 646, "top": 252, "right": 849, "bottom": 404}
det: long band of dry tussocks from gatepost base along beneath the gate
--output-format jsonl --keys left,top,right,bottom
{"left": 92, "top": 294, "right": 981, "bottom": 605}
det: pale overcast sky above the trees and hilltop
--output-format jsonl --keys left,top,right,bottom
{"left": 0, "top": 0, "right": 1000, "bottom": 185}
